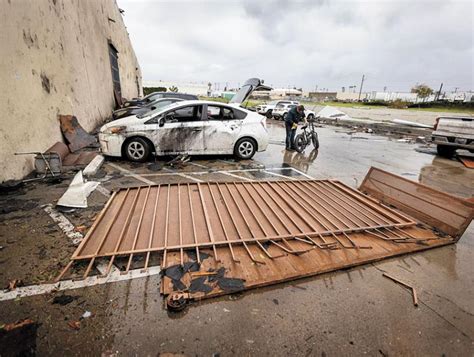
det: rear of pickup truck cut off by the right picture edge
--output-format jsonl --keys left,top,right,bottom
{"left": 431, "top": 117, "right": 474, "bottom": 157}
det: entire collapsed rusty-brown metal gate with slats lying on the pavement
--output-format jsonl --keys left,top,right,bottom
{"left": 58, "top": 169, "right": 472, "bottom": 307}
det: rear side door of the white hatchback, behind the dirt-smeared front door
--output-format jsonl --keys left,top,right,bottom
{"left": 203, "top": 104, "right": 245, "bottom": 154}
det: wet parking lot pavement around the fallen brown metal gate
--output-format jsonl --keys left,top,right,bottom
{"left": 0, "top": 121, "right": 474, "bottom": 356}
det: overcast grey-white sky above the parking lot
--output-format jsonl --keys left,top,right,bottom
{"left": 118, "top": 0, "right": 474, "bottom": 91}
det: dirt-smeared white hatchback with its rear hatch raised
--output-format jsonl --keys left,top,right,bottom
{"left": 99, "top": 78, "right": 268, "bottom": 162}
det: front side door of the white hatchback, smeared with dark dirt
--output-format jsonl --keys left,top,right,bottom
{"left": 148, "top": 105, "right": 204, "bottom": 155}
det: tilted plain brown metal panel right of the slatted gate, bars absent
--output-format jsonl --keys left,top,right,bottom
{"left": 359, "top": 167, "right": 474, "bottom": 239}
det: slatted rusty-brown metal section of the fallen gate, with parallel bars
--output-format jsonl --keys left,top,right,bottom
{"left": 56, "top": 180, "right": 416, "bottom": 276}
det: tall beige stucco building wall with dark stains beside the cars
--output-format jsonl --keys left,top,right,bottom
{"left": 0, "top": 0, "right": 142, "bottom": 182}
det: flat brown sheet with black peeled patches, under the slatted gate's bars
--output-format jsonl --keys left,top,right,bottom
{"left": 161, "top": 226, "right": 454, "bottom": 307}
